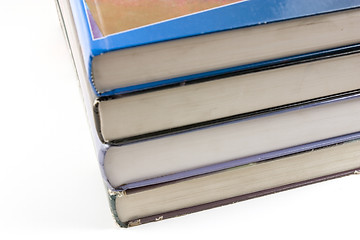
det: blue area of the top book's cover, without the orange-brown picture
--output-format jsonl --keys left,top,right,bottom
{"left": 70, "top": 0, "right": 360, "bottom": 96}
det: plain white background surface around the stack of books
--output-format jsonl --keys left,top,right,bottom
{"left": 0, "top": 0, "right": 360, "bottom": 239}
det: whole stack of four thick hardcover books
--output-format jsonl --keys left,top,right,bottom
{"left": 56, "top": 0, "right": 360, "bottom": 227}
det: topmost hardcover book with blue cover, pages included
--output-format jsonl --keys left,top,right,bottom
{"left": 69, "top": 0, "right": 360, "bottom": 97}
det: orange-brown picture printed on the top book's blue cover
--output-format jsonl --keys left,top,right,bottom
{"left": 86, "top": 0, "right": 243, "bottom": 38}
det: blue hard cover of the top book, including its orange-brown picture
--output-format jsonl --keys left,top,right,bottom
{"left": 70, "top": 0, "right": 360, "bottom": 96}
